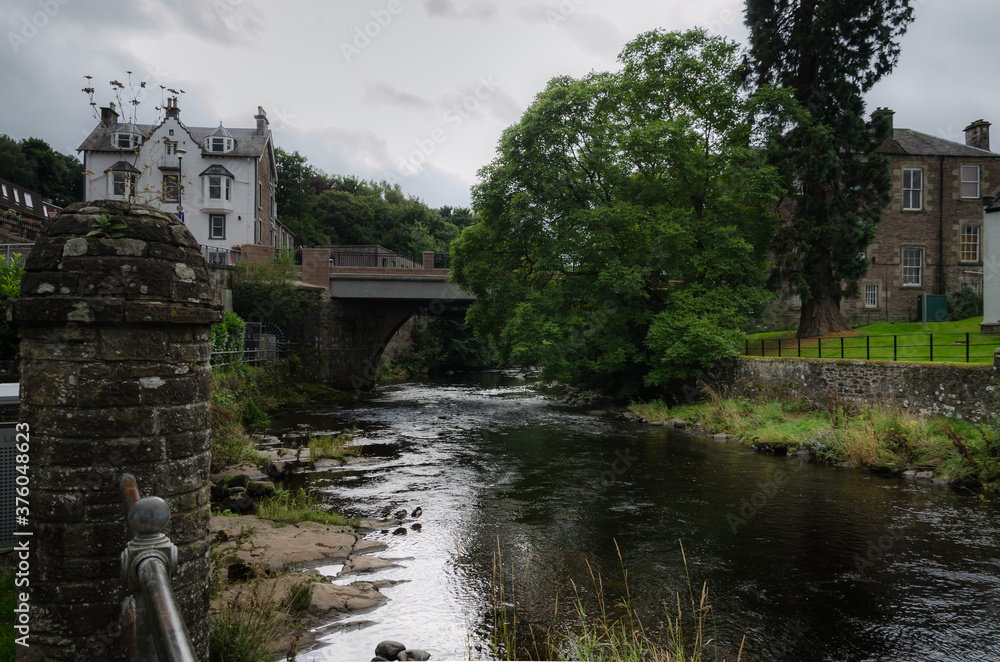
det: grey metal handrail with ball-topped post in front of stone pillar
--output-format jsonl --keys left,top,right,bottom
{"left": 118, "top": 474, "right": 198, "bottom": 662}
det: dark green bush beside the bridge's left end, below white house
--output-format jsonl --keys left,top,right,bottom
{"left": 233, "top": 253, "right": 301, "bottom": 326}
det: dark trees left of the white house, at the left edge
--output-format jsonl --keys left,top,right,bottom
{"left": 0, "top": 135, "right": 83, "bottom": 207}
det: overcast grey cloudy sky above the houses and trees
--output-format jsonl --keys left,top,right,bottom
{"left": 0, "top": 0, "right": 1000, "bottom": 207}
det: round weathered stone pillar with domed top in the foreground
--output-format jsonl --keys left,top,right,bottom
{"left": 8, "top": 201, "right": 221, "bottom": 660}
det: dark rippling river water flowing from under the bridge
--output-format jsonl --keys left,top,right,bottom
{"left": 266, "top": 372, "right": 1000, "bottom": 662}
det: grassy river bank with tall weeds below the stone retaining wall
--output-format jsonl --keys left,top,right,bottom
{"left": 623, "top": 393, "right": 1000, "bottom": 492}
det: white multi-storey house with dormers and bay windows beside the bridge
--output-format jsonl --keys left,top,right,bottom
{"left": 78, "top": 98, "right": 295, "bottom": 262}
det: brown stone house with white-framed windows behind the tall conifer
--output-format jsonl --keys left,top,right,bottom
{"left": 772, "top": 108, "right": 1000, "bottom": 324}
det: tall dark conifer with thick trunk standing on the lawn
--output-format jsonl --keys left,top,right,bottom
{"left": 746, "top": 0, "right": 913, "bottom": 337}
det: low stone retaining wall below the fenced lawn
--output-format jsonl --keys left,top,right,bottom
{"left": 733, "top": 357, "right": 998, "bottom": 422}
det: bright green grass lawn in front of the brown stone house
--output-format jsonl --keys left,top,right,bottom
{"left": 746, "top": 317, "right": 1000, "bottom": 363}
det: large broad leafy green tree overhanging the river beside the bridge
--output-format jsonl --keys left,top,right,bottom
{"left": 452, "top": 30, "right": 780, "bottom": 396}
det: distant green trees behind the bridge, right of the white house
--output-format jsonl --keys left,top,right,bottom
{"left": 275, "top": 148, "right": 472, "bottom": 254}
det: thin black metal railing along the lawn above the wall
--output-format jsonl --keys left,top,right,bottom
{"left": 744, "top": 333, "right": 1000, "bottom": 363}
